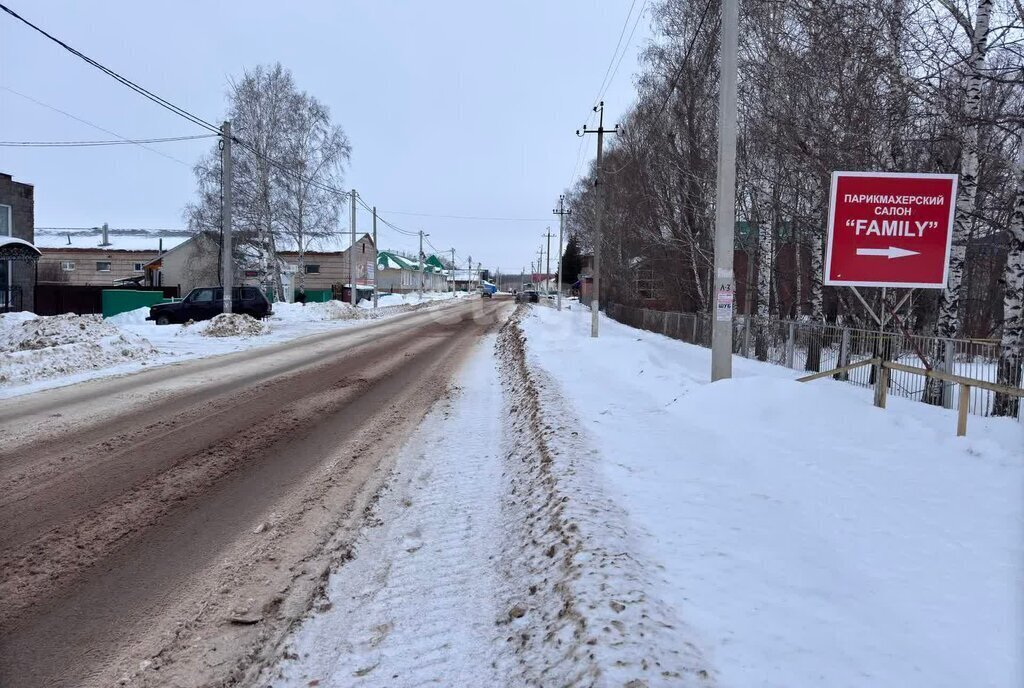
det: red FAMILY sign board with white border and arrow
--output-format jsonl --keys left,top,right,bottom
{"left": 824, "top": 172, "right": 956, "bottom": 289}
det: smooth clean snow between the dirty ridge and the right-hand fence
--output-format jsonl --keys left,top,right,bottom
{"left": 524, "top": 308, "right": 1024, "bottom": 688}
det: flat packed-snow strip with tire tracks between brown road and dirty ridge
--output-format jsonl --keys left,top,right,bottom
{"left": 262, "top": 337, "right": 502, "bottom": 686}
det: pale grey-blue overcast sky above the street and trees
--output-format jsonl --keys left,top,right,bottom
{"left": 0, "top": 0, "right": 650, "bottom": 272}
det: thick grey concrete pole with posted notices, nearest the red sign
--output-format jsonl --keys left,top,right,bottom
{"left": 711, "top": 0, "right": 739, "bottom": 382}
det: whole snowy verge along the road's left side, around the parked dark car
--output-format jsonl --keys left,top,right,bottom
{"left": 0, "top": 293, "right": 467, "bottom": 398}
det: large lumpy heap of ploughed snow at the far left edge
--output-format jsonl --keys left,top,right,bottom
{"left": 0, "top": 313, "right": 157, "bottom": 386}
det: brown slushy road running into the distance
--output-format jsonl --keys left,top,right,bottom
{"left": 0, "top": 300, "right": 509, "bottom": 687}
